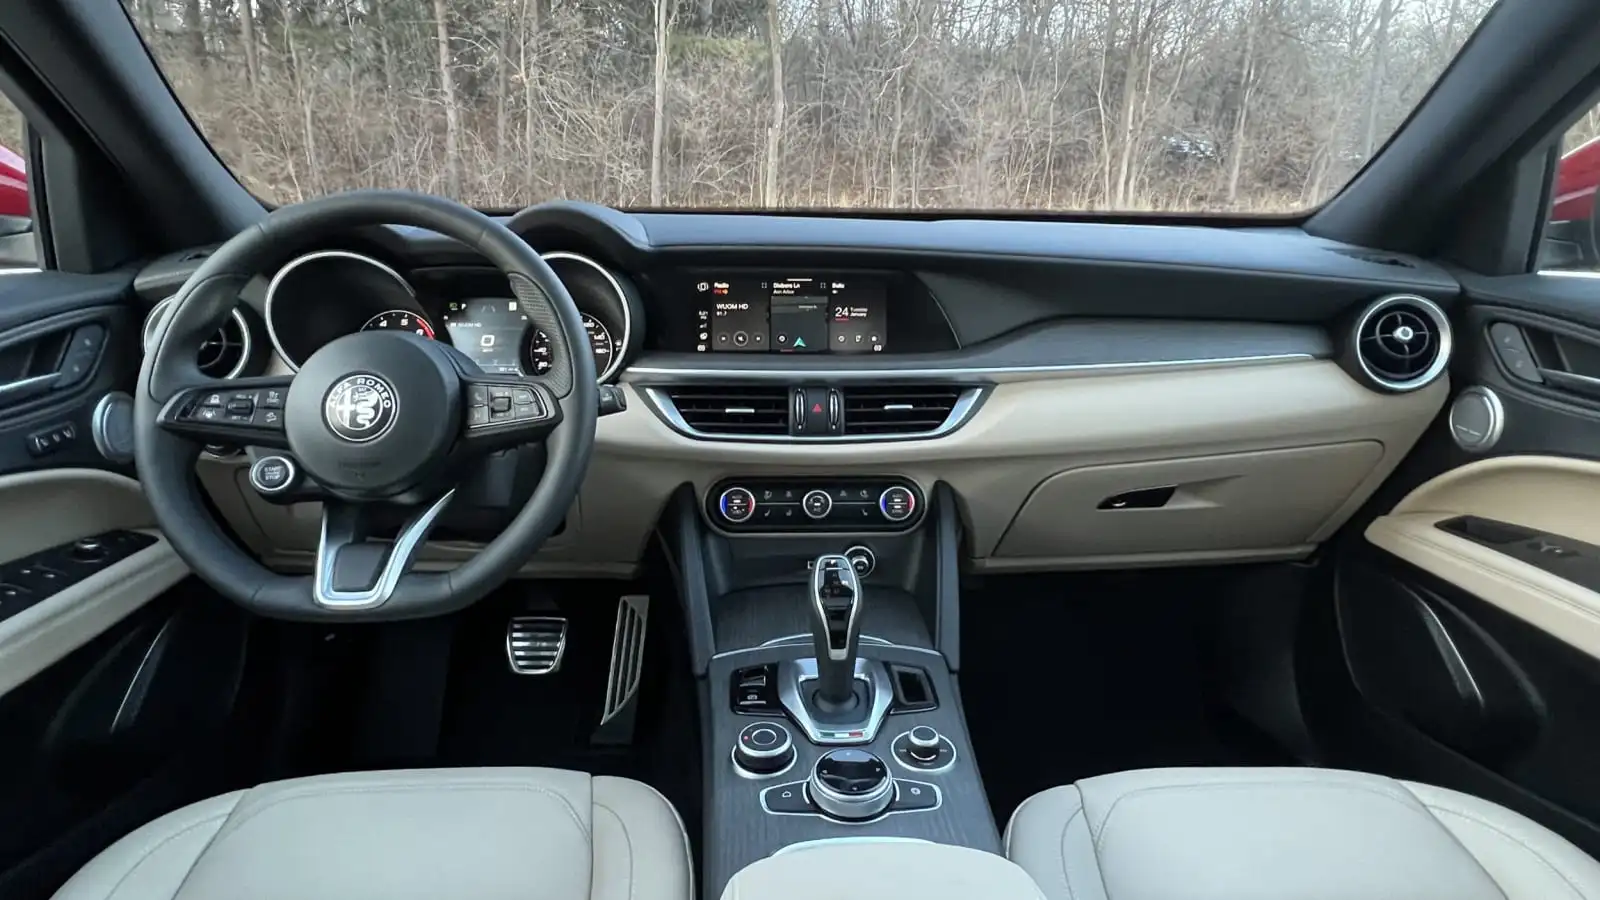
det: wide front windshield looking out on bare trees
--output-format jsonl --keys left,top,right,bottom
{"left": 130, "top": 0, "right": 1493, "bottom": 213}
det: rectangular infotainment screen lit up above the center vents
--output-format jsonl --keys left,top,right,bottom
{"left": 693, "top": 272, "right": 888, "bottom": 354}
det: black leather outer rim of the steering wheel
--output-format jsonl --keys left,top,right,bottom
{"left": 134, "top": 191, "right": 598, "bottom": 621}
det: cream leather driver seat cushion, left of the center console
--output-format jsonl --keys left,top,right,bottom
{"left": 56, "top": 769, "right": 694, "bottom": 900}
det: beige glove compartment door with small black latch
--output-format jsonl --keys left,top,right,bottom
{"left": 994, "top": 440, "right": 1384, "bottom": 559}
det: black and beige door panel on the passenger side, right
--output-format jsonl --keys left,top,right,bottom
{"left": 1301, "top": 274, "right": 1600, "bottom": 855}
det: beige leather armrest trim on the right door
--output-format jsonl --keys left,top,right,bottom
{"left": 1366, "top": 456, "right": 1600, "bottom": 658}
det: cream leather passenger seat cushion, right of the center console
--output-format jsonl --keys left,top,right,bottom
{"left": 1005, "top": 769, "right": 1600, "bottom": 900}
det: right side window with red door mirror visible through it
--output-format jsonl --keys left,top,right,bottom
{"left": 1539, "top": 106, "right": 1600, "bottom": 272}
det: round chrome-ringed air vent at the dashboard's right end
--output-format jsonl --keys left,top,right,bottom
{"left": 1355, "top": 293, "right": 1451, "bottom": 391}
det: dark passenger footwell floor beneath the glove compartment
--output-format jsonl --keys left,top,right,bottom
{"left": 960, "top": 570, "right": 1293, "bottom": 826}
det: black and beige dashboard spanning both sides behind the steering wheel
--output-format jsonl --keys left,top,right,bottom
{"left": 134, "top": 202, "right": 1459, "bottom": 578}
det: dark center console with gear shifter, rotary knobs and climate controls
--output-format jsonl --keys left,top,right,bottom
{"left": 667, "top": 486, "right": 1000, "bottom": 897}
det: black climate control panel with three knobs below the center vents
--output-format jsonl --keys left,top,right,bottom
{"left": 706, "top": 477, "right": 923, "bottom": 533}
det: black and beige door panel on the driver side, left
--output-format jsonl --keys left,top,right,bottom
{"left": 0, "top": 272, "right": 248, "bottom": 897}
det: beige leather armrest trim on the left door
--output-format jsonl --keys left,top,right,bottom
{"left": 0, "top": 469, "right": 189, "bottom": 695}
